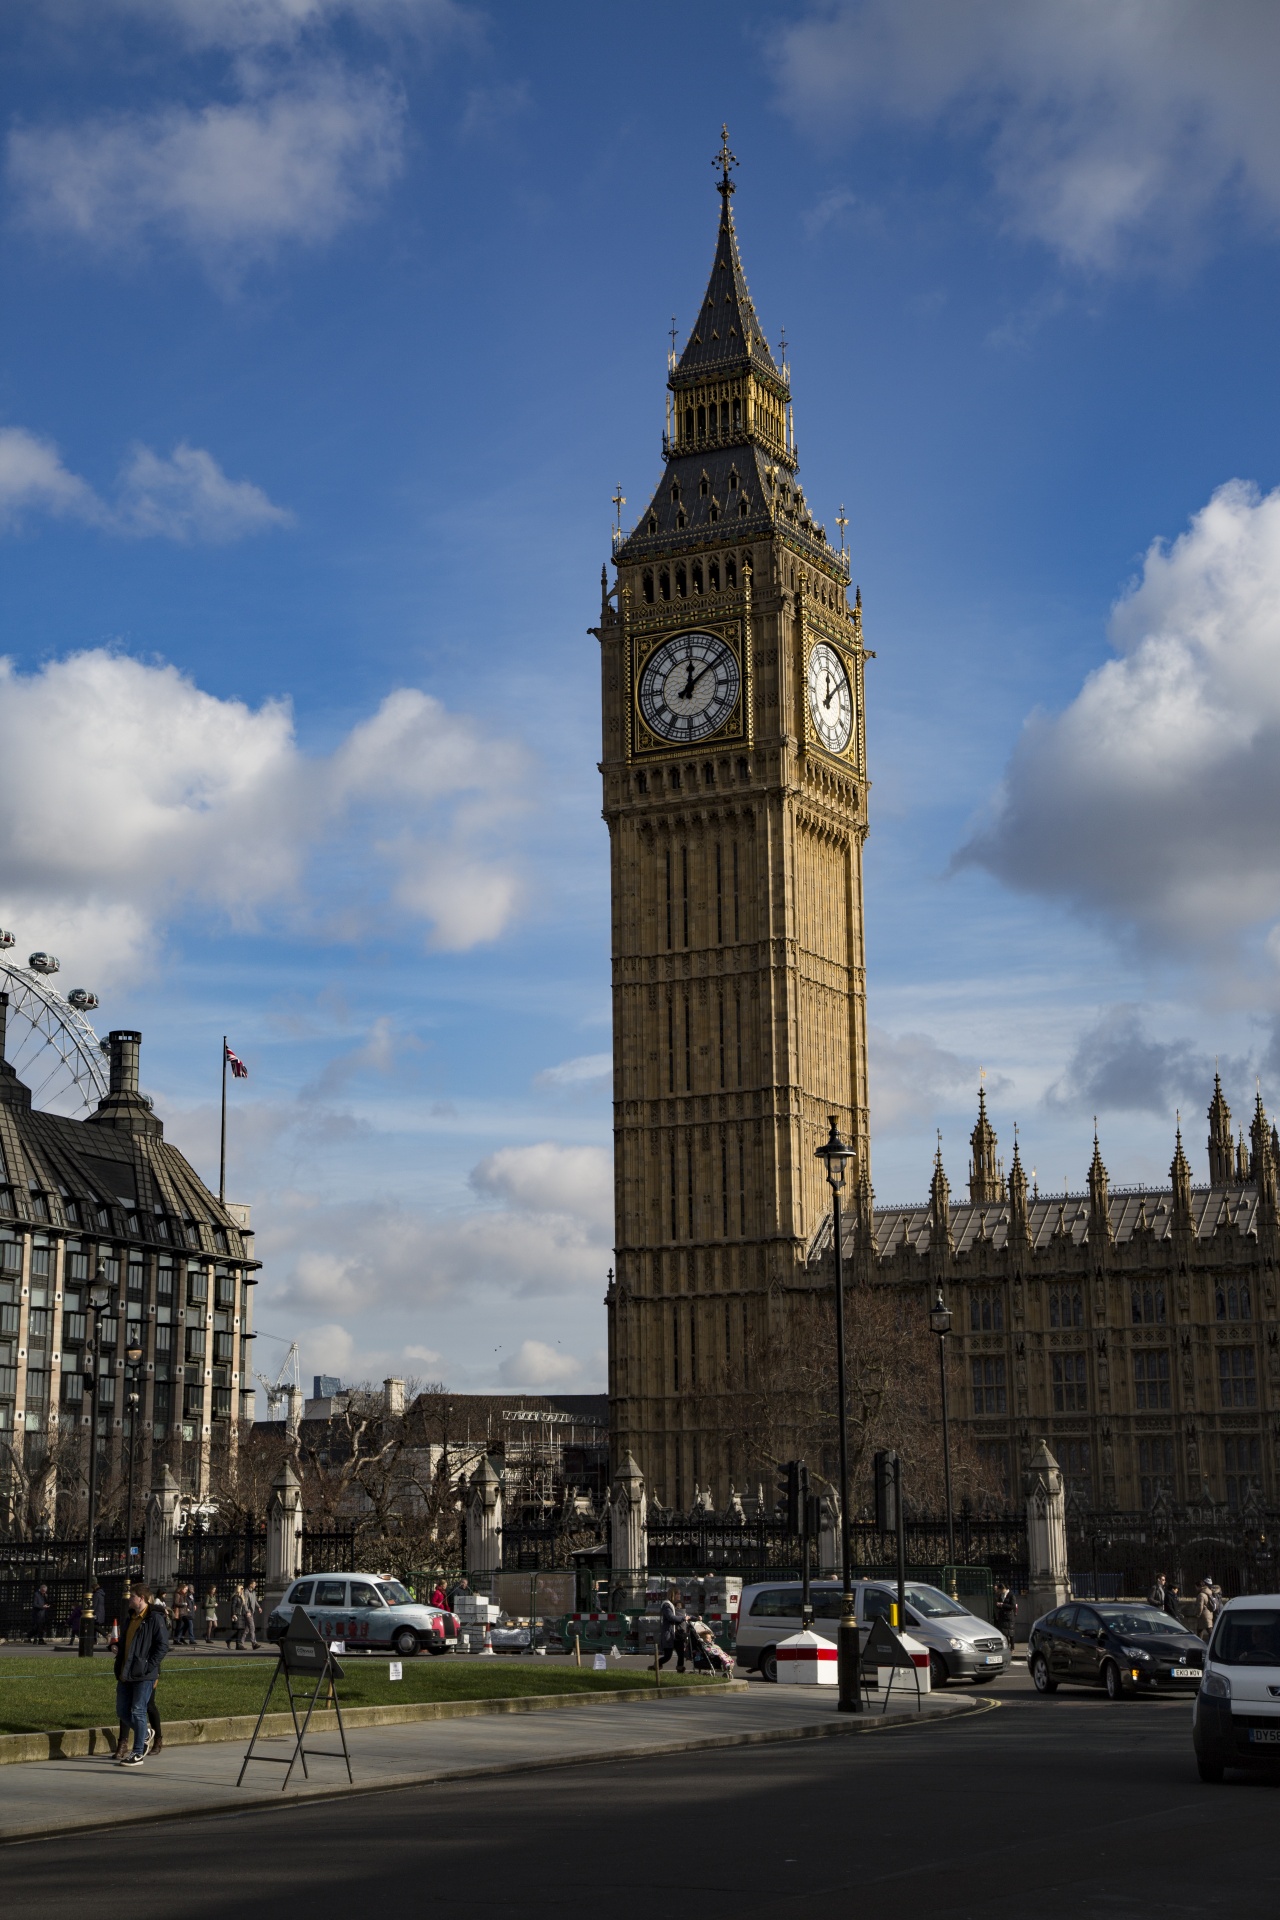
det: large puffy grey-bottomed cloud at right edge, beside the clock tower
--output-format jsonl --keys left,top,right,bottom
{"left": 958, "top": 480, "right": 1280, "bottom": 952}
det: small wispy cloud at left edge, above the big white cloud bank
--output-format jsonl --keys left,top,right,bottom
{"left": 0, "top": 426, "right": 294, "bottom": 545}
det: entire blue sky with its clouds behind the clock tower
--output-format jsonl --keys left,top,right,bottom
{"left": 0, "top": 0, "right": 1280, "bottom": 1390}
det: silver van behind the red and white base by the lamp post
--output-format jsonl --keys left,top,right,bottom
{"left": 735, "top": 1580, "right": 1009, "bottom": 1688}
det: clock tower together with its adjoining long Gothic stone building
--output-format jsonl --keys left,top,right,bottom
{"left": 593, "top": 138, "right": 1280, "bottom": 1509}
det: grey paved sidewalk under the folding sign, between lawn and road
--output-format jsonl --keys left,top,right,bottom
{"left": 0, "top": 1682, "right": 994, "bottom": 1841}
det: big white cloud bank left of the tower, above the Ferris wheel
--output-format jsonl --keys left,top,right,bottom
{"left": 0, "top": 651, "right": 522, "bottom": 983}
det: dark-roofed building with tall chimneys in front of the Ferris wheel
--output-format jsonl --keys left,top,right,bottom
{"left": 0, "top": 995, "right": 259, "bottom": 1524}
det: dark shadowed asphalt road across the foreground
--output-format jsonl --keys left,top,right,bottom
{"left": 4, "top": 1672, "right": 1280, "bottom": 1920}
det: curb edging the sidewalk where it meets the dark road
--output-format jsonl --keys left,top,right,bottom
{"left": 0, "top": 1682, "right": 1002, "bottom": 1847}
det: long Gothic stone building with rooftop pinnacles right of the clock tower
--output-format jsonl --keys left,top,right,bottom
{"left": 840, "top": 1079, "right": 1280, "bottom": 1511}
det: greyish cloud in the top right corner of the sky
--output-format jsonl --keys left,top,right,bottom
{"left": 775, "top": 0, "right": 1280, "bottom": 269}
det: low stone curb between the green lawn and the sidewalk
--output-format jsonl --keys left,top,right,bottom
{"left": 0, "top": 1680, "right": 748, "bottom": 1766}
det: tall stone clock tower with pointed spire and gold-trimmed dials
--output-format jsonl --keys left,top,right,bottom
{"left": 595, "top": 136, "right": 869, "bottom": 1507}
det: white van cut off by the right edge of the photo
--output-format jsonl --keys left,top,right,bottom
{"left": 1192, "top": 1594, "right": 1280, "bottom": 1784}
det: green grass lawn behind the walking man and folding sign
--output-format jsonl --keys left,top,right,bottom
{"left": 0, "top": 1655, "right": 712, "bottom": 1734}
